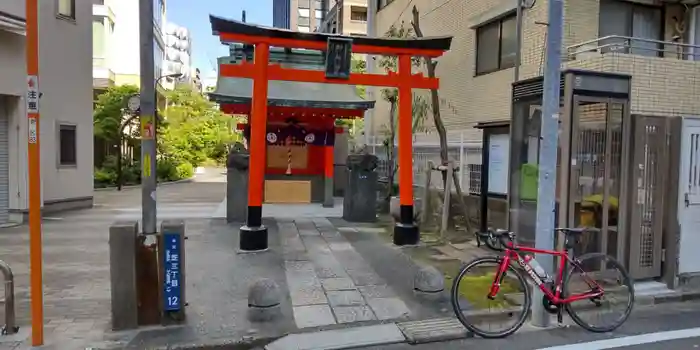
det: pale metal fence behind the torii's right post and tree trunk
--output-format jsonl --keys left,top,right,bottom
{"left": 367, "top": 132, "right": 482, "bottom": 194}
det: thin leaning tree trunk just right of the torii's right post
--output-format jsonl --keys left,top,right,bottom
{"left": 411, "top": 5, "right": 472, "bottom": 232}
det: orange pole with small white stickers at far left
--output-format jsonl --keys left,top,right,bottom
{"left": 24, "top": 0, "right": 44, "bottom": 346}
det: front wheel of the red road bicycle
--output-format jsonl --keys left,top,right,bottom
{"left": 451, "top": 257, "right": 532, "bottom": 338}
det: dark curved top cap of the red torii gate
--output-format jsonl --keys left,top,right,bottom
{"left": 209, "top": 15, "right": 452, "bottom": 51}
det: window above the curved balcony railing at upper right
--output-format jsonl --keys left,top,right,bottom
{"left": 598, "top": 0, "right": 663, "bottom": 56}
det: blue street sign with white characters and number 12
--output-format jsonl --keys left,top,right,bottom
{"left": 163, "top": 233, "right": 182, "bottom": 311}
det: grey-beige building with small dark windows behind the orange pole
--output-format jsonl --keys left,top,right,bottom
{"left": 0, "top": 0, "right": 93, "bottom": 226}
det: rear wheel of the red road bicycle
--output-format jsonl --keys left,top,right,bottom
{"left": 564, "top": 253, "right": 634, "bottom": 333}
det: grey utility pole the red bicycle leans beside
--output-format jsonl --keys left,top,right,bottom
{"left": 531, "top": 0, "right": 568, "bottom": 327}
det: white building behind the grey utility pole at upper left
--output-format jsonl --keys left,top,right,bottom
{"left": 92, "top": 0, "right": 173, "bottom": 98}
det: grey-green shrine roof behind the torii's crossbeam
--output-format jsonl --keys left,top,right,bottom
{"left": 209, "top": 57, "right": 375, "bottom": 109}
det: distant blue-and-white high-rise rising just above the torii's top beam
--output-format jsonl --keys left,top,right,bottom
{"left": 272, "top": 0, "right": 324, "bottom": 32}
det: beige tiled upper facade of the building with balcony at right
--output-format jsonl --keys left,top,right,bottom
{"left": 373, "top": 0, "right": 700, "bottom": 141}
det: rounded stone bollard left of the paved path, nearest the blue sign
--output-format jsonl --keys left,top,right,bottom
{"left": 248, "top": 278, "right": 282, "bottom": 322}
